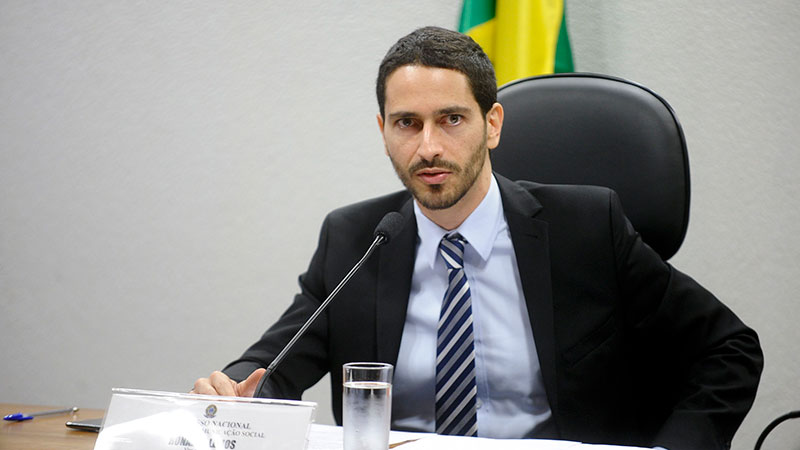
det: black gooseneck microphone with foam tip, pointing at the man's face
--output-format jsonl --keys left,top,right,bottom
{"left": 253, "top": 211, "right": 404, "bottom": 397}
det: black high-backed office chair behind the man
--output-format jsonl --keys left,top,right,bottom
{"left": 491, "top": 73, "right": 690, "bottom": 260}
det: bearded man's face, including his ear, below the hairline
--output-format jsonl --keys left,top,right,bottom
{"left": 378, "top": 65, "right": 502, "bottom": 210}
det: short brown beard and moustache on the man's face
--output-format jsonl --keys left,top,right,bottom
{"left": 389, "top": 130, "right": 489, "bottom": 210}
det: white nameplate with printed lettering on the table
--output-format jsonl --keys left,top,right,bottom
{"left": 94, "top": 389, "right": 317, "bottom": 450}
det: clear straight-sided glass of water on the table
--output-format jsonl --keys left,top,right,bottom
{"left": 342, "top": 362, "right": 394, "bottom": 450}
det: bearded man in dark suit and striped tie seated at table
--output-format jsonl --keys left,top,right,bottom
{"left": 193, "top": 27, "right": 762, "bottom": 450}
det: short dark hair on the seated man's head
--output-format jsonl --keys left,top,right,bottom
{"left": 376, "top": 27, "right": 497, "bottom": 116}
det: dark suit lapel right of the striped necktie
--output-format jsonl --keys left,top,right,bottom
{"left": 495, "top": 174, "right": 558, "bottom": 418}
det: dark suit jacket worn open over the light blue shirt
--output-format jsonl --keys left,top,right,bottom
{"left": 225, "top": 176, "right": 763, "bottom": 450}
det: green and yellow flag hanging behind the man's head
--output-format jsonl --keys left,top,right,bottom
{"left": 458, "top": 0, "right": 574, "bottom": 85}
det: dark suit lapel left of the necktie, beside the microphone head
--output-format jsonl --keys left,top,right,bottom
{"left": 376, "top": 199, "right": 417, "bottom": 365}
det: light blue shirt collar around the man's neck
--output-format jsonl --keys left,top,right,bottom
{"left": 414, "top": 175, "right": 505, "bottom": 268}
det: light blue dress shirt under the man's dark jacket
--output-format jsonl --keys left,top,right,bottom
{"left": 392, "top": 177, "right": 552, "bottom": 438}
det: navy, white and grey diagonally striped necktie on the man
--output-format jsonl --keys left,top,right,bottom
{"left": 436, "top": 233, "right": 478, "bottom": 436}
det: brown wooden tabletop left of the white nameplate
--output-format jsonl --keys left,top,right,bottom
{"left": 0, "top": 403, "right": 105, "bottom": 450}
